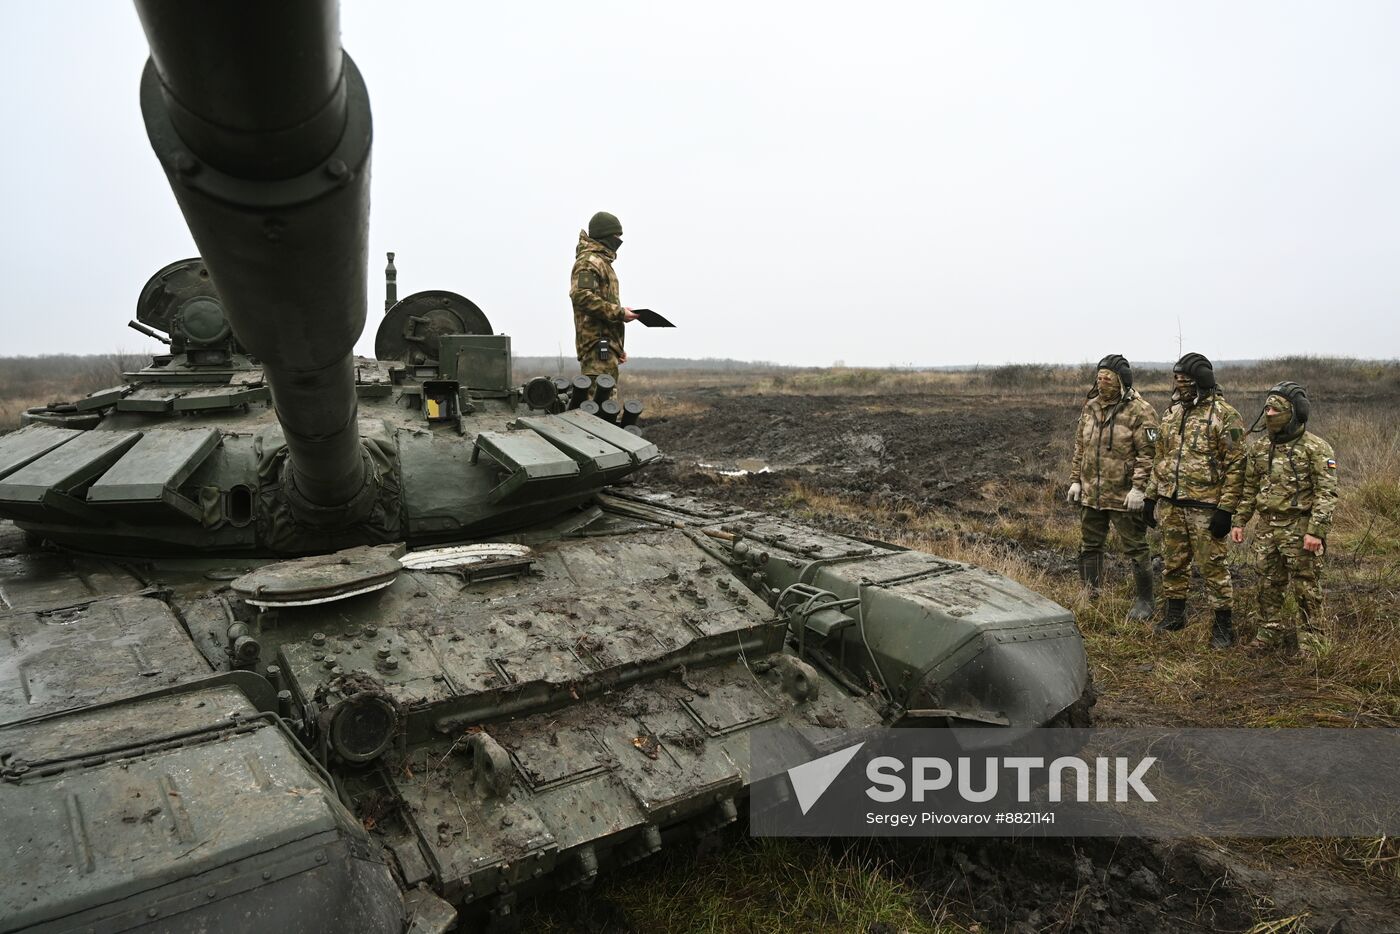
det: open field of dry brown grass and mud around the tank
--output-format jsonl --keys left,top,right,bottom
{"left": 0, "top": 357, "right": 1400, "bottom": 934}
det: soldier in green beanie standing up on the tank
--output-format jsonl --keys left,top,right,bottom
{"left": 568, "top": 211, "right": 637, "bottom": 397}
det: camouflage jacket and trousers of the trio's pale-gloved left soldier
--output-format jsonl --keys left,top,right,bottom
{"left": 1070, "top": 388, "right": 1158, "bottom": 564}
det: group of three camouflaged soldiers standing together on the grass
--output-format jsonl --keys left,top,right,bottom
{"left": 1067, "top": 353, "right": 1337, "bottom": 654}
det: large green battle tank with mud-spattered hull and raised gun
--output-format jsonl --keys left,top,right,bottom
{"left": 0, "top": 0, "right": 1092, "bottom": 931}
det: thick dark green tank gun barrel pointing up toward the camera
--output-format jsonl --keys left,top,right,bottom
{"left": 136, "top": 0, "right": 374, "bottom": 525}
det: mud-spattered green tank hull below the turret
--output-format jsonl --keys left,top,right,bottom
{"left": 0, "top": 490, "right": 1088, "bottom": 931}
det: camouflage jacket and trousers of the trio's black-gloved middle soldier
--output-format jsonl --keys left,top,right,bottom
{"left": 1147, "top": 389, "right": 1245, "bottom": 611}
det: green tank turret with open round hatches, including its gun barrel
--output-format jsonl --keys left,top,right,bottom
{"left": 0, "top": 0, "right": 658, "bottom": 555}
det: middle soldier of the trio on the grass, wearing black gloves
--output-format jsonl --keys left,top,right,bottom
{"left": 1145, "top": 353, "right": 1245, "bottom": 648}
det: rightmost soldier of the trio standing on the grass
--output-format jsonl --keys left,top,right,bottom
{"left": 1231, "top": 381, "right": 1337, "bottom": 654}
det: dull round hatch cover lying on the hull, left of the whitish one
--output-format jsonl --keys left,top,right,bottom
{"left": 230, "top": 545, "right": 403, "bottom": 606}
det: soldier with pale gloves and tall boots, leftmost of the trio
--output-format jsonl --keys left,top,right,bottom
{"left": 1067, "top": 353, "right": 1158, "bottom": 619}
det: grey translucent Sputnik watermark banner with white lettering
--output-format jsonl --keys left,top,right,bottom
{"left": 750, "top": 728, "right": 1400, "bottom": 836}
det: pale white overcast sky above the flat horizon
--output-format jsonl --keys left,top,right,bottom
{"left": 0, "top": 0, "right": 1400, "bottom": 365}
